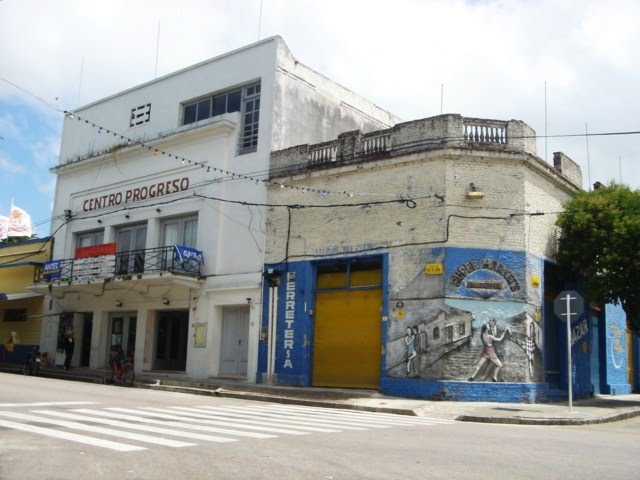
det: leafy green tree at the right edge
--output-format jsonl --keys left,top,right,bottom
{"left": 556, "top": 183, "right": 640, "bottom": 332}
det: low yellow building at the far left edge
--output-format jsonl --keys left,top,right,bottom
{"left": 0, "top": 237, "right": 51, "bottom": 363}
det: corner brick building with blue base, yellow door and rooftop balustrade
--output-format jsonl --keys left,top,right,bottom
{"left": 258, "top": 115, "right": 630, "bottom": 402}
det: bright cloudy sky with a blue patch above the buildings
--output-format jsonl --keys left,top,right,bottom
{"left": 0, "top": 0, "right": 640, "bottom": 236}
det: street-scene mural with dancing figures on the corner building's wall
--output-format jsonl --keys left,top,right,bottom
{"left": 386, "top": 249, "right": 543, "bottom": 382}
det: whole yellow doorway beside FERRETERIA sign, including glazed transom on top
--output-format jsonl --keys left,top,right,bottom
{"left": 312, "top": 261, "right": 382, "bottom": 388}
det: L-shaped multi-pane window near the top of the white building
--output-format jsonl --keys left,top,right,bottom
{"left": 182, "top": 83, "right": 261, "bottom": 153}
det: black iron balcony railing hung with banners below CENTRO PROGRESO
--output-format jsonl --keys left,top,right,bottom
{"left": 34, "top": 246, "right": 202, "bottom": 284}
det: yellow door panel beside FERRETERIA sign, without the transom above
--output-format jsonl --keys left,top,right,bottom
{"left": 312, "top": 278, "right": 382, "bottom": 388}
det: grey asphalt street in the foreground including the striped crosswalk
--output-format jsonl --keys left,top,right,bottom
{"left": 0, "top": 373, "right": 640, "bottom": 480}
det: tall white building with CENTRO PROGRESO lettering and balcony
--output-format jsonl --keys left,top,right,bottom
{"left": 32, "top": 37, "right": 396, "bottom": 382}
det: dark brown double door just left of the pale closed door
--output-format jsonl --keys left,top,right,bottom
{"left": 153, "top": 310, "right": 189, "bottom": 372}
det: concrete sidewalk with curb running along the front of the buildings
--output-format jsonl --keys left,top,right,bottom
{"left": 0, "top": 364, "right": 640, "bottom": 425}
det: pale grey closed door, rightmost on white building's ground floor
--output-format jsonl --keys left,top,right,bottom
{"left": 220, "top": 307, "right": 249, "bottom": 376}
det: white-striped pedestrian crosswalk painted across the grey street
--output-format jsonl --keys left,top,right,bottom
{"left": 0, "top": 402, "right": 453, "bottom": 452}
